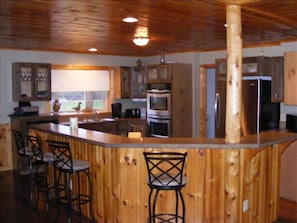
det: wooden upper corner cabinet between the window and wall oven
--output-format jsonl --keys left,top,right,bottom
{"left": 121, "top": 67, "right": 147, "bottom": 98}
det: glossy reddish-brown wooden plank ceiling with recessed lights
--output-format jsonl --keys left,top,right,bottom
{"left": 0, "top": 0, "right": 297, "bottom": 56}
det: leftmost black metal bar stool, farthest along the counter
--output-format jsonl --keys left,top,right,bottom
{"left": 12, "top": 130, "right": 39, "bottom": 207}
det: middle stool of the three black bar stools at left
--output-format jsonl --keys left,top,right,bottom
{"left": 27, "top": 135, "right": 54, "bottom": 212}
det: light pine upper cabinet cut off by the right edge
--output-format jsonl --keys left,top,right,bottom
{"left": 284, "top": 51, "right": 297, "bottom": 105}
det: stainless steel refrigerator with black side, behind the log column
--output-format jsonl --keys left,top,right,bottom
{"left": 215, "top": 76, "right": 280, "bottom": 138}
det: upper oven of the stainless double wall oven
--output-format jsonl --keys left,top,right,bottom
{"left": 147, "top": 89, "right": 171, "bottom": 117}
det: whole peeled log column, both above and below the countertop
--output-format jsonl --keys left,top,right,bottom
{"left": 225, "top": 5, "right": 242, "bottom": 223}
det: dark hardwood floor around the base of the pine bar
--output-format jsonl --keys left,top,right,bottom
{"left": 0, "top": 171, "right": 297, "bottom": 223}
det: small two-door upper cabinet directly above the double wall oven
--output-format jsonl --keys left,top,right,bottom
{"left": 147, "top": 64, "right": 172, "bottom": 83}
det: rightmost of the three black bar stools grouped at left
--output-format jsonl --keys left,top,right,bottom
{"left": 46, "top": 140, "right": 94, "bottom": 222}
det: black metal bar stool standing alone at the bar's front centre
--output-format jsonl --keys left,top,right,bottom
{"left": 143, "top": 152, "right": 187, "bottom": 223}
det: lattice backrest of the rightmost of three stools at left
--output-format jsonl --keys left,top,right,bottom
{"left": 46, "top": 140, "right": 73, "bottom": 173}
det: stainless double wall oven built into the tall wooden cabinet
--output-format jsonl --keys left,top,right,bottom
{"left": 147, "top": 83, "right": 171, "bottom": 138}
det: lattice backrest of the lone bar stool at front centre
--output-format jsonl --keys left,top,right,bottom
{"left": 143, "top": 152, "right": 187, "bottom": 190}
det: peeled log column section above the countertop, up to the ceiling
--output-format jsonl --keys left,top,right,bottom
{"left": 225, "top": 5, "right": 242, "bottom": 143}
